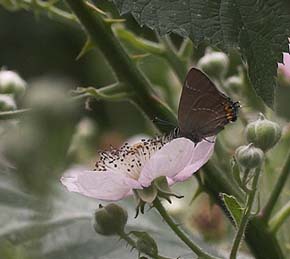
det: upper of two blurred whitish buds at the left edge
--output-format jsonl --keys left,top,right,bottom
{"left": 0, "top": 70, "right": 27, "bottom": 95}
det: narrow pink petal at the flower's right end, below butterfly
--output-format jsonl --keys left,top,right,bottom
{"left": 173, "top": 138, "right": 215, "bottom": 182}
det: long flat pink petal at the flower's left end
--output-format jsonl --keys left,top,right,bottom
{"left": 61, "top": 168, "right": 142, "bottom": 201}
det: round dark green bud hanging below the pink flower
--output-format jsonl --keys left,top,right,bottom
{"left": 94, "top": 203, "right": 128, "bottom": 236}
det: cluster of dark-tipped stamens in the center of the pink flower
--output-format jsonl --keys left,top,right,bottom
{"left": 95, "top": 135, "right": 172, "bottom": 180}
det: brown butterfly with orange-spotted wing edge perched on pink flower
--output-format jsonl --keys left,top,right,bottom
{"left": 178, "top": 68, "right": 240, "bottom": 143}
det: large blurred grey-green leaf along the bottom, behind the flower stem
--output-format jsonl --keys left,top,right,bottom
{"left": 0, "top": 173, "right": 222, "bottom": 259}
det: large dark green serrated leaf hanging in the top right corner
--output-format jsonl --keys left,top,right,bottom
{"left": 112, "top": 0, "right": 290, "bottom": 107}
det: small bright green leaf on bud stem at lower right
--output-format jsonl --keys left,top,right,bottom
{"left": 221, "top": 193, "right": 244, "bottom": 227}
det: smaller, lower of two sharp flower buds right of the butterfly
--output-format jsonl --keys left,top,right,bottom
{"left": 235, "top": 143, "right": 264, "bottom": 169}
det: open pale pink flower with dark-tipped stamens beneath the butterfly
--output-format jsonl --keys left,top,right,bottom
{"left": 61, "top": 137, "right": 214, "bottom": 201}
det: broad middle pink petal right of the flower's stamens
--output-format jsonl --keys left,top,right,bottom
{"left": 138, "top": 138, "right": 194, "bottom": 186}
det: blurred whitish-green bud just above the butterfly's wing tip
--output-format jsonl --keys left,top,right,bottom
{"left": 197, "top": 49, "right": 229, "bottom": 79}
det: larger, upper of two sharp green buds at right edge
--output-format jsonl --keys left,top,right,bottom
{"left": 246, "top": 113, "right": 281, "bottom": 151}
